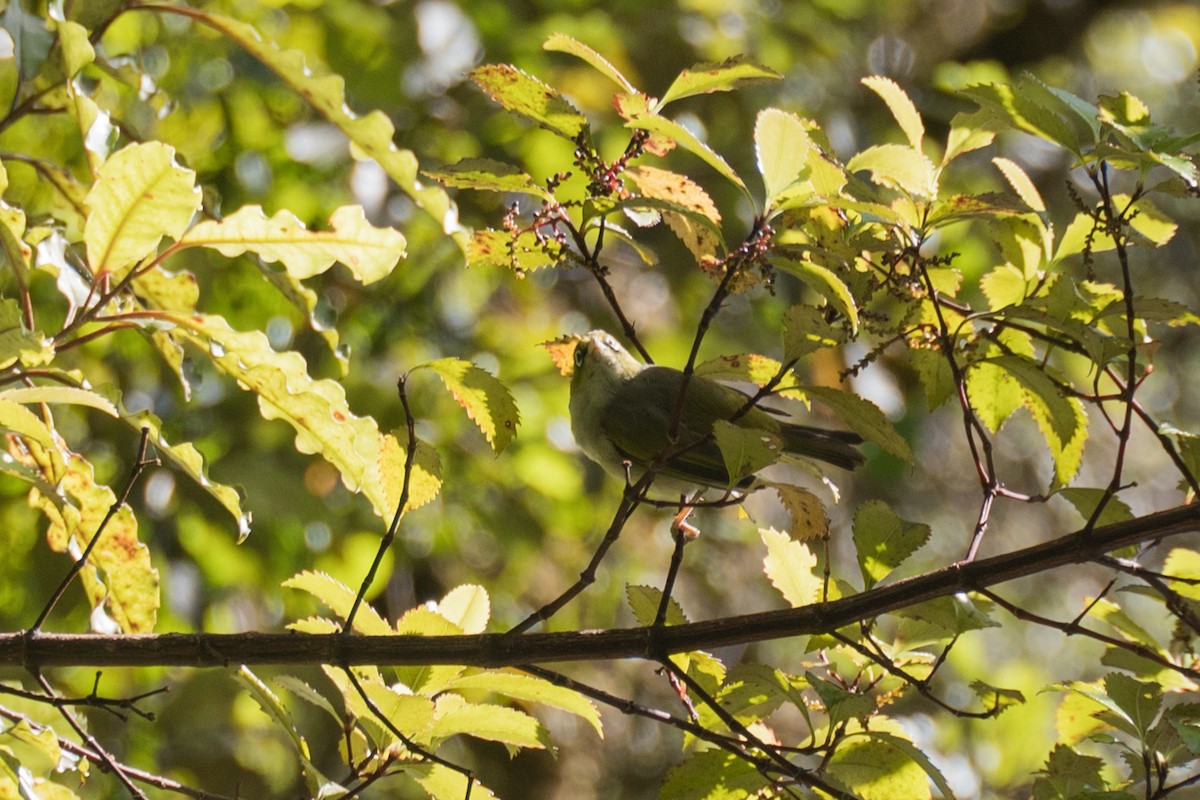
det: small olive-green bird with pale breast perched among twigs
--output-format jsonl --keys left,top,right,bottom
{"left": 547, "top": 331, "right": 864, "bottom": 495}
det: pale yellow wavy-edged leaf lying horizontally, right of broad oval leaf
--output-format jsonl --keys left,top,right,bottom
{"left": 180, "top": 205, "right": 406, "bottom": 284}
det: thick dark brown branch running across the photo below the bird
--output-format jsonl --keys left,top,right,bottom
{"left": 0, "top": 504, "right": 1200, "bottom": 669}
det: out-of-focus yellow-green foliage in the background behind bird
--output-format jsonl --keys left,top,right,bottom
{"left": 0, "top": 0, "right": 1200, "bottom": 798}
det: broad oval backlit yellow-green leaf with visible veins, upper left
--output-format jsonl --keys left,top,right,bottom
{"left": 83, "top": 142, "right": 200, "bottom": 275}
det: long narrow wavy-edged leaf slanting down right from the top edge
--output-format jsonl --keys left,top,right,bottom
{"left": 190, "top": 8, "right": 469, "bottom": 252}
